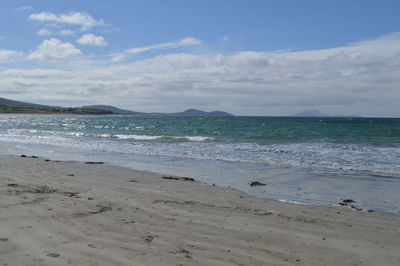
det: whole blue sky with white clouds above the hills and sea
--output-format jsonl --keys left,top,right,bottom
{"left": 0, "top": 0, "right": 400, "bottom": 117}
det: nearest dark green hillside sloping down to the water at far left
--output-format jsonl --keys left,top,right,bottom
{"left": 0, "top": 98, "right": 112, "bottom": 114}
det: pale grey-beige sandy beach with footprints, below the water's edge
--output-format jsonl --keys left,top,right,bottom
{"left": 0, "top": 156, "right": 400, "bottom": 266}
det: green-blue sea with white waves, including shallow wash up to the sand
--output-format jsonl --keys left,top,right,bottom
{"left": 0, "top": 114, "right": 400, "bottom": 212}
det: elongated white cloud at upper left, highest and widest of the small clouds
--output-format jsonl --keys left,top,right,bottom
{"left": 29, "top": 12, "right": 106, "bottom": 31}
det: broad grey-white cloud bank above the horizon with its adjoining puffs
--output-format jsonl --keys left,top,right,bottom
{"left": 0, "top": 33, "right": 400, "bottom": 116}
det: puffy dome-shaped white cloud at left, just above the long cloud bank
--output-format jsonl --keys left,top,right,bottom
{"left": 28, "top": 39, "right": 81, "bottom": 61}
